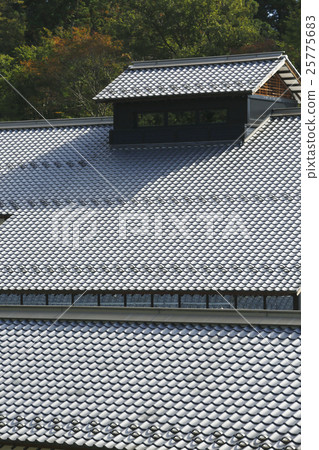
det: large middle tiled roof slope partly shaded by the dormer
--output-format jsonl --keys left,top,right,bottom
{"left": 0, "top": 116, "right": 300, "bottom": 291}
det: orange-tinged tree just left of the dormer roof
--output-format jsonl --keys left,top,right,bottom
{"left": 28, "top": 27, "right": 129, "bottom": 117}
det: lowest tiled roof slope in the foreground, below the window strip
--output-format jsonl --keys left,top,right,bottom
{"left": 0, "top": 319, "right": 300, "bottom": 450}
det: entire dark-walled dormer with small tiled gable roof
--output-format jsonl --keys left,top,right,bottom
{"left": 95, "top": 52, "right": 301, "bottom": 144}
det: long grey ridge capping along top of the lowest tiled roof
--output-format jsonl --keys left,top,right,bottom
{"left": 0, "top": 305, "right": 301, "bottom": 326}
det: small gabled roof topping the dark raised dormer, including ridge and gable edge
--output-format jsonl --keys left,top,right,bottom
{"left": 94, "top": 52, "right": 301, "bottom": 101}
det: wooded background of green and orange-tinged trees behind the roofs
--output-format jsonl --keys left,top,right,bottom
{"left": 0, "top": 0, "right": 301, "bottom": 121}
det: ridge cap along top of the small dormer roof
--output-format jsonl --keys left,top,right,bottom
{"left": 128, "top": 51, "right": 284, "bottom": 70}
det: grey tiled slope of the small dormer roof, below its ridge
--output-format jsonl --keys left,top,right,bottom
{"left": 94, "top": 55, "right": 286, "bottom": 100}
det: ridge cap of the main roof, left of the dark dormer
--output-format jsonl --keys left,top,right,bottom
{"left": 0, "top": 116, "right": 113, "bottom": 130}
